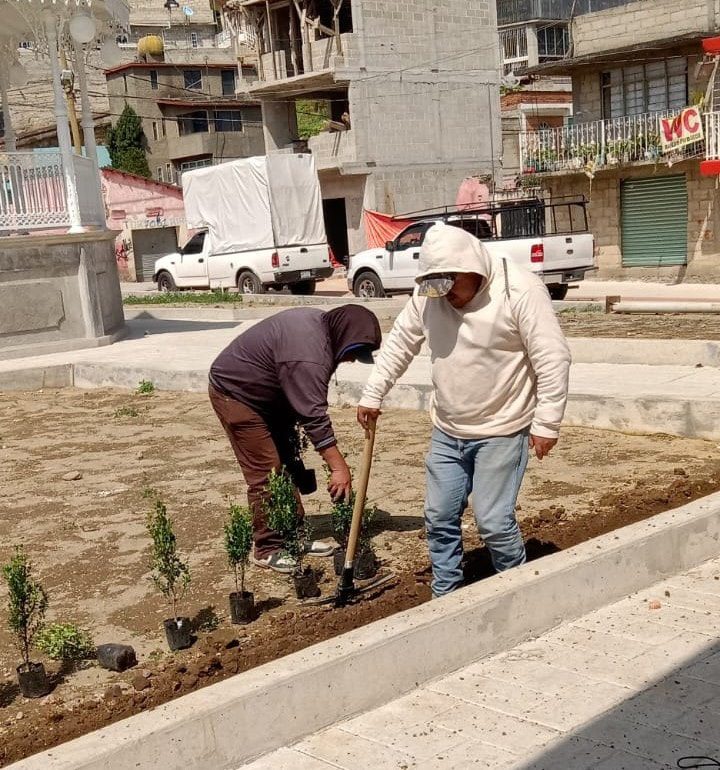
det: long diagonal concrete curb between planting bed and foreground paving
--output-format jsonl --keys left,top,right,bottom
{"left": 11, "top": 493, "right": 720, "bottom": 770}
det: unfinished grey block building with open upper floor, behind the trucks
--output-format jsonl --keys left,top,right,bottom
{"left": 225, "top": 0, "right": 501, "bottom": 257}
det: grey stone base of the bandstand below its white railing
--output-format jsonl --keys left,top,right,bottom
{"left": 0, "top": 232, "right": 125, "bottom": 358}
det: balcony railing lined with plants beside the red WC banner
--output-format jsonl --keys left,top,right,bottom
{"left": 520, "top": 110, "right": 705, "bottom": 174}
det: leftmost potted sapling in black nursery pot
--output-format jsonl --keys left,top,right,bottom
{"left": 3, "top": 547, "right": 50, "bottom": 698}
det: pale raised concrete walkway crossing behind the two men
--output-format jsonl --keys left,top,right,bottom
{"left": 0, "top": 319, "right": 720, "bottom": 439}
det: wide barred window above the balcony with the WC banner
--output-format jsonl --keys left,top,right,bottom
{"left": 600, "top": 57, "right": 688, "bottom": 120}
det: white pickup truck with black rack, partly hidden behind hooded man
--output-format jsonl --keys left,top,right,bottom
{"left": 348, "top": 198, "right": 595, "bottom": 299}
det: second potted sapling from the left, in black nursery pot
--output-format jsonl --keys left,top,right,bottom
{"left": 147, "top": 500, "right": 192, "bottom": 651}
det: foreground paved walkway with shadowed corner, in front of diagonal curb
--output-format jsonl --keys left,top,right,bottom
{"left": 242, "top": 559, "right": 720, "bottom": 770}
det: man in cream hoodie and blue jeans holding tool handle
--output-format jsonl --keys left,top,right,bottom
{"left": 358, "top": 223, "right": 570, "bottom": 596}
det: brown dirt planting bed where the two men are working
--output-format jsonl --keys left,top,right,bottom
{"left": 0, "top": 390, "right": 720, "bottom": 764}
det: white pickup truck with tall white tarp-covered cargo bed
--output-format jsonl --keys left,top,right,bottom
{"left": 153, "top": 153, "right": 333, "bottom": 294}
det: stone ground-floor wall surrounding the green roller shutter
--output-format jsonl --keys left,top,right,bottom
{"left": 545, "top": 160, "right": 720, "bottom": 282}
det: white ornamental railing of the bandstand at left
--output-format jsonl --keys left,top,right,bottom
{"left": 0, "top": 151, "right": 105, "bottom": 232}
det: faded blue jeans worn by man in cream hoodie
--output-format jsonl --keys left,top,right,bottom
{"left": 425, "top": 428, "right": 528, "bottom": 596}
